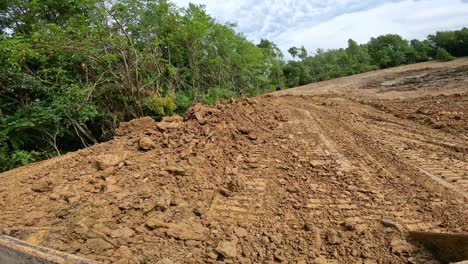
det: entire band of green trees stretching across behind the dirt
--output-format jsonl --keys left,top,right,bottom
{"left": 0, "top": 0, "right": 468, "bottom": 171}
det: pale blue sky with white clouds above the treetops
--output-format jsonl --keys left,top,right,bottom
{"left": 172, "top": 0, "right": 468, "bottom": 53}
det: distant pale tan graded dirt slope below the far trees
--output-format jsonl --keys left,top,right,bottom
{"left": 276, "top": 58, "right": 468, "bottom": 99}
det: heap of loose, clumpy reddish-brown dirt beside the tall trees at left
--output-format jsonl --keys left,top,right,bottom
{"left": 1, "top": 99, "right": 292, "bottom": 263}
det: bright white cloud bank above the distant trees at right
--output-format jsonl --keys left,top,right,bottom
{"left": 275, "top": 0, "right": 468, "bottom": 54}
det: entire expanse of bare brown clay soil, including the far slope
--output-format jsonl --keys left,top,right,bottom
{"left": 0, "top": 57, "right": 468, "bottom": 264}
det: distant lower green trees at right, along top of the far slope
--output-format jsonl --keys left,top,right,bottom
{"left": 282, "top": 28, "right": 468, "bottom": 87}
